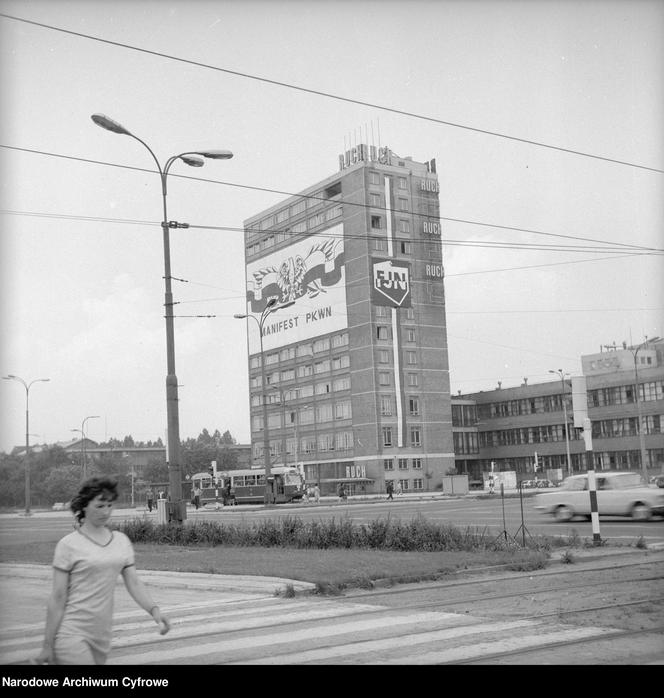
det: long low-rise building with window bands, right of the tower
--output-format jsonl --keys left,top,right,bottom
{"left": 452, "top": 338, "right": 664, "bottom": 482}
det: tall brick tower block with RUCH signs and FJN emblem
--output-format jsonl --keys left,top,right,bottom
{"left": 244, "top": 145, "right": 454, "bottom": 494}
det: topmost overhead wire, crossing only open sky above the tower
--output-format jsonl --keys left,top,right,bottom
{"left": 0, "top": 13, "right": 664, "bottom": 174}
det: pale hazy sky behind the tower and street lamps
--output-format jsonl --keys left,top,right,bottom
{"left": 0, "top": 0, "right": 664, "bottom": 452}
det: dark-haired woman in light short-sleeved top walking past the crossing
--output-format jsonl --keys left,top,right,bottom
{"left": 35, "top": 477, "right": 170, "bottom": 664}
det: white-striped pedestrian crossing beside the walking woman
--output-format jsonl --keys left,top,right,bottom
{"left": 0, "top": 594, "right": 619, "bottom": 666}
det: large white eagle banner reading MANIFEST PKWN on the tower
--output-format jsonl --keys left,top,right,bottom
{"left": 247, "top": 224, "right": 348, "bottom": 354}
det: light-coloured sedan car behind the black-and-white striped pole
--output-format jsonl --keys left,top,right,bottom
{"left": 533, "top": 472, "right": 664, "bottom": 521}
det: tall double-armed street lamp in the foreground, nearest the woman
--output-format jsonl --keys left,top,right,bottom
{"left": 90, "top": 114, "right": 233, "bottom": 522}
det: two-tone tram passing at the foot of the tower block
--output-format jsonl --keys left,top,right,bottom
{"left": 191, "top": 465, "right": 305, "bottom": 506}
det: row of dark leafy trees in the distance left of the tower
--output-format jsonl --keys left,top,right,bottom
{"left": 0, "top": 429, "right": 243, "bottom": 508}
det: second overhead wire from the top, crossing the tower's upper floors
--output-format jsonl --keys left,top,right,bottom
{"left": 0, "top": 144, "right": 664, "bottom": 252}
